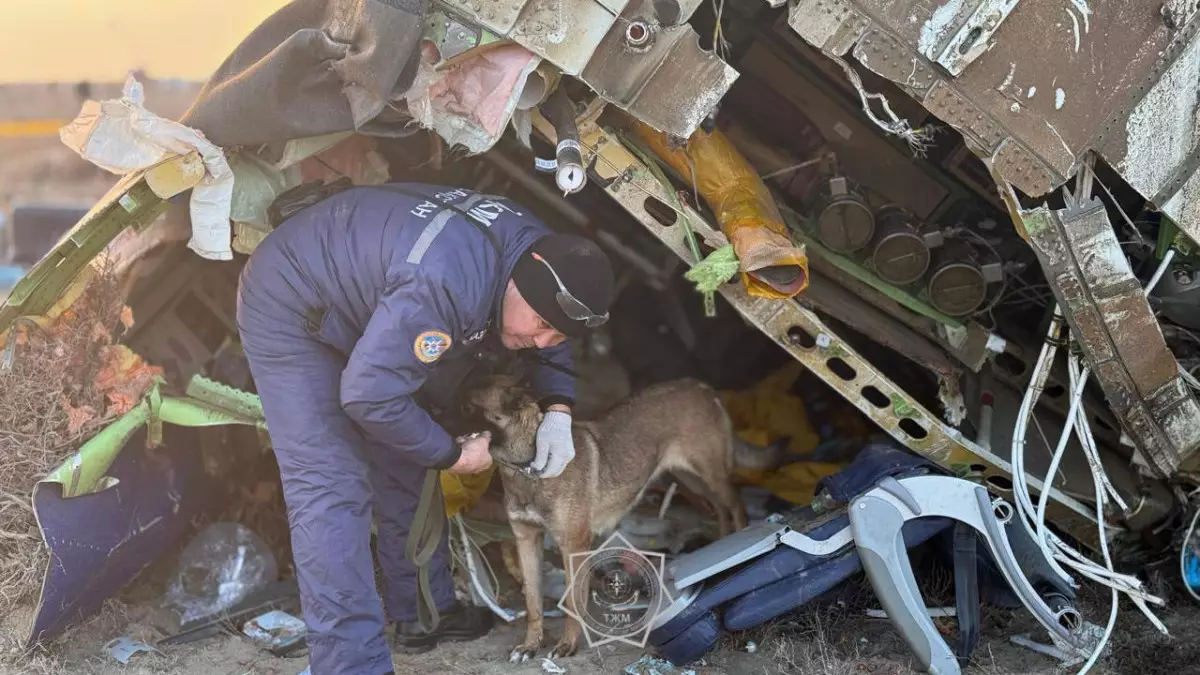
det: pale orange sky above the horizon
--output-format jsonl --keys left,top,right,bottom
{"left": 0, "top": 0, "right": 287, "bottom": 83}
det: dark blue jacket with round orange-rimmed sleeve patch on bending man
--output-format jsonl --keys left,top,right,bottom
{"left": 242, "top": 184, "right": 575, "bottom": 468}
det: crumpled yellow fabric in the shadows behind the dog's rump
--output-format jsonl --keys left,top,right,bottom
{"left": 721, "top": 362, "right": 842, "bottom": 504}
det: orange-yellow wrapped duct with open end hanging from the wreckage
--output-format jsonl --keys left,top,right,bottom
{"left": 635, "top": 123, "right": 809, "bottom": 299}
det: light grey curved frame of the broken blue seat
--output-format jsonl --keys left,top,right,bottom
{"left": 655, "top": 476, "right": 1076, "bottom": 675}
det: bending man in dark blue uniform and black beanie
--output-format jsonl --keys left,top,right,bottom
{"left": 238, "top": 184, "right": 614, "bottom": 675}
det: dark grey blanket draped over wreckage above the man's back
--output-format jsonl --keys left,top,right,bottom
{"left": 180, "top": 0, "right": 428, "bottom": 148}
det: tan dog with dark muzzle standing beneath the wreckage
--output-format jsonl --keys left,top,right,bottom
{"left": 466, "top": 376, "right": 746, "bottom": 662}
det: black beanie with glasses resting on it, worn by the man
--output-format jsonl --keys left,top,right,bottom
{"left": 512, "top": 234, "right": 616, "bottom": 338}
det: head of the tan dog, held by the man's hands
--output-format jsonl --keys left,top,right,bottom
{"left": 462, "top": 375, "right": 541, "bottom": 465}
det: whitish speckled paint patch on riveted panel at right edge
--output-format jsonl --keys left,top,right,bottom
{"left": 1118, "top": 40, "right": 1200, "bottom": 196}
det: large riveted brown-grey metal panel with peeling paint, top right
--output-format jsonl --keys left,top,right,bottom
{"left": 787, "top": 0, "right": 1200, "bottom": 228}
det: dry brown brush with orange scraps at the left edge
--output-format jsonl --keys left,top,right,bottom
{"left": 0, "top": 260, "right": 154, "bottom": 616}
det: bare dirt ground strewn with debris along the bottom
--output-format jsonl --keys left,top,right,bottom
{"left": 7, "top": 569, "right": 1200, "bottom": 675}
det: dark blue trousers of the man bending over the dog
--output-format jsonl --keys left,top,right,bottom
{"left": 238, "top": 293, "right": 455, "bottom": 675}
